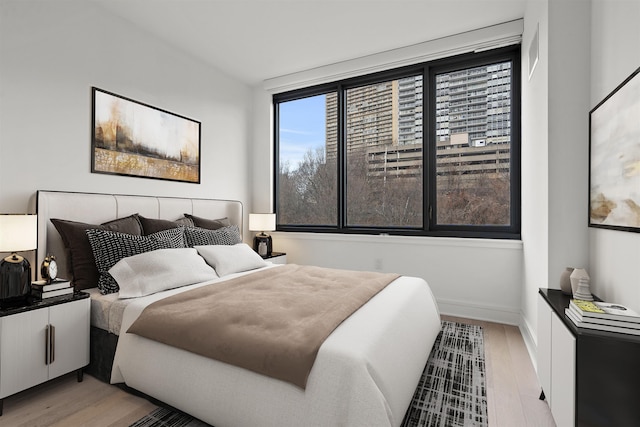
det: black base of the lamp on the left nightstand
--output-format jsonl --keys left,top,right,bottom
{"left": 0, "top": 254, "right": 31, "bottom": 307}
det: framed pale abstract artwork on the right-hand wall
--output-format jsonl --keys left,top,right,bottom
{"left": 589, "top": 68, "right": 640, "bottom": 233}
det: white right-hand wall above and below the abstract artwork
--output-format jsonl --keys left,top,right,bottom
{"left": 588, "top": 0, "right": 640, "bottom": 311}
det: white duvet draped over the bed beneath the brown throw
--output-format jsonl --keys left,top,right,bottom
{"left": 111, "top": 267, "right": 440, "bottom": 427}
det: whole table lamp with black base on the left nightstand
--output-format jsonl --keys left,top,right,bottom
{"left": 0, "top": 214, "right": 38, "bottom": 306}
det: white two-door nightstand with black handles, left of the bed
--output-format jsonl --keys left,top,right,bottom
{"left": 0, "top": 292, "right": 91, "bottom": 415}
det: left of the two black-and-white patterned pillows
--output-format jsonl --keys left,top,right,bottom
{"left": 86, "top": 227, "right": 184, "bottom": 294}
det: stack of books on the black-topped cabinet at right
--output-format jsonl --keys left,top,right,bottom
{"left": 565, "top": 299, "right": 640, "bottom": 335}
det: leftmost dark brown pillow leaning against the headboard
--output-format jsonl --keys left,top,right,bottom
{"left": 51, "top": 215, "right": 142, "bottom": 290}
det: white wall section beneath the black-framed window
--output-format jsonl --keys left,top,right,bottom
{"left": 273, "top": 233, "right": 522, "bottom": 325}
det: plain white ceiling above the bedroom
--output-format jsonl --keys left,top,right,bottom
{"left": 94, "top": 0, "right": 526, "bottom": 85}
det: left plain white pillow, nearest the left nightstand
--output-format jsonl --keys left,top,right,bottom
{"left": 109, "top": 248, "right": 218, "bottom": 298}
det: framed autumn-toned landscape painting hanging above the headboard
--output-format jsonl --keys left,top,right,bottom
{"left": 91, "top": 87, "right": 201, "bottom": 184}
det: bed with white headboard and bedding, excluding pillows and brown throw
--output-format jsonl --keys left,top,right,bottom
{"left": 36, "top": 191, "right": 440, "bottom": 427}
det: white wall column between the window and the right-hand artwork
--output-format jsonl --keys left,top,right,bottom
{"left": 522, "top": 0, "right": 591, "bottom": 360}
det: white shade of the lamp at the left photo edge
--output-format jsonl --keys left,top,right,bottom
{"left": 0, "top": 214, "right": 38, "bottom": 252}
